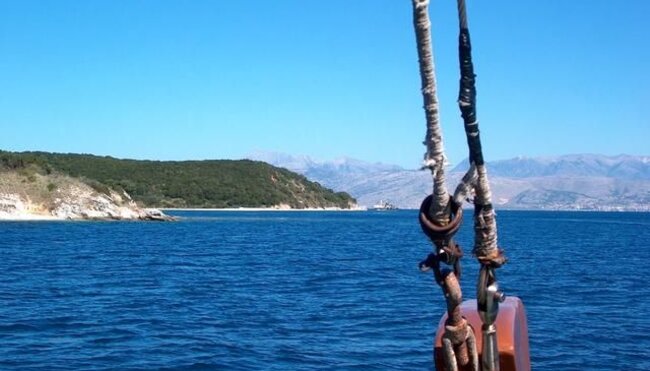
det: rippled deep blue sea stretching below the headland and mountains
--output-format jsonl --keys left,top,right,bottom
{"left": 0, "top": 211, "right": 650, "bottom": 370}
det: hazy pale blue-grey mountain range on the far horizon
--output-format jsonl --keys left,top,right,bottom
{"left": 244, "top": 152, "right": 650, "bottom": 211}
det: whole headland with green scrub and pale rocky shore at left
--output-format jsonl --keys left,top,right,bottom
{"left": 0, "top": 151, "right": 356, "bottom": 220}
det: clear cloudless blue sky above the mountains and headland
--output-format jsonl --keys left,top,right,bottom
{"left": 0, "top": 0, "right": 650, "bottom": 168}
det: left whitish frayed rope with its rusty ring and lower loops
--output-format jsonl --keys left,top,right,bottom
{"left": 413, "top": 0, "right": 478, "bottom": 371}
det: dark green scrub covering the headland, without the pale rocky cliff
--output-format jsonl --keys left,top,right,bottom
{"left": 0, "top": 151, "right": 354, "bottom": 208}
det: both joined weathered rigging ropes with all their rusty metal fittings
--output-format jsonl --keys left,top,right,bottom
{"left": 412, "top": 0, "right": 505, "bottom": 371}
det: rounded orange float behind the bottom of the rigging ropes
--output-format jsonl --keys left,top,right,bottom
{"left": 434, "top": 296, "right": 530, "bottom": 371}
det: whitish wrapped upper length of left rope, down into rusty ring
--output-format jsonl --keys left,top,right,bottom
{"left": 413, "top": 0, "right": 450, "bottom": 225}
